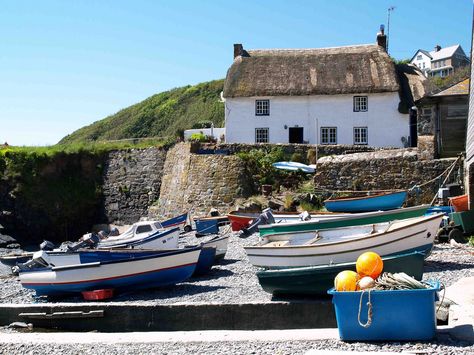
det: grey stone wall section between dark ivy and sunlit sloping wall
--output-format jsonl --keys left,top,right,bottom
{"left": 103, "top": 148, "right": 166, "bottom": 224}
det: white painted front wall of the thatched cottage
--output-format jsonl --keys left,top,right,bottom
{"left": 225, "top": 92, "right": 409, "bottom": 147}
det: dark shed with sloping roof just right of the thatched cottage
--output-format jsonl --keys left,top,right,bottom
{"left": 416, "top": 79, "right": 469, "bottom": 158}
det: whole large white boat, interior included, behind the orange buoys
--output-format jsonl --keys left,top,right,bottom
{"left": 245, "top": 213, "right": 443, "bottom": 268}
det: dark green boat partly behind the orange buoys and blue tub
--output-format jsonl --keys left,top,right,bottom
{"left": 257, "top": 251, "right": 426, "bottom": 296}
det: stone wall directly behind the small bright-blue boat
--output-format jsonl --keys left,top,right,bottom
{"left": 314, "top": 149, "right": 459, "bottom": 203}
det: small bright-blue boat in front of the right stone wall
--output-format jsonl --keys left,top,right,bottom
{"left": 324, "top": 191, "right": 407, "bottom": 212}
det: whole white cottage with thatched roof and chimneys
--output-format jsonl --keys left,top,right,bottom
{"left": 223, "top": 30, "right": 424, "bottom": 147}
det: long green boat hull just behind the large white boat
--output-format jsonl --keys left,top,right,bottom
{"left": 258, "top": 205, "right": 430, "bottom": 237}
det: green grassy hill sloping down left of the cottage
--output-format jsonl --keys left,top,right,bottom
{"left": 59, "top": 79, "right": 224, "bottom": 145}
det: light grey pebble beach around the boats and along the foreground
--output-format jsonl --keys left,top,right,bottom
{"left": 0, "top": 233, "right": 474, "bottom": 354}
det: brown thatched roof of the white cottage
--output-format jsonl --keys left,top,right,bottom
{"left": 224, "top": 45, "right": 400, "bottom": 97}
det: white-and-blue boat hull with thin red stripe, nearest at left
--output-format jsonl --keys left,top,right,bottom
{"left": 19, "top": 247, "right": 201, "bottom": 296}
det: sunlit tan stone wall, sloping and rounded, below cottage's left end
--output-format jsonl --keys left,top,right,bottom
{"left": 149, "top": 143, "right": 251, "bottom": 217}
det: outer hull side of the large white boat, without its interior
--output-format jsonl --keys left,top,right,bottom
{"left": 245, "top": 214, "right": 443, "bottom": 268}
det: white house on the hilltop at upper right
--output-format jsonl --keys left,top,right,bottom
{"left": 410, "top": 44, "right": 469, "bottom": 77}
